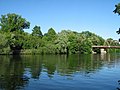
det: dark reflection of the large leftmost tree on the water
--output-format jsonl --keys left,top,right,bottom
{"left": 0, "top": 56, "right": 28, "bottom": 90}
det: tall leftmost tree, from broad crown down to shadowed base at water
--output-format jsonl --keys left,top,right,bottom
{"left": 0, "top": 13, "right": 30, "bottom": 54}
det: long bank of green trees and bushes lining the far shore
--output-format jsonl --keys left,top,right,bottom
{"left": 0, "top": 13, "right": 119, "bottom": 54}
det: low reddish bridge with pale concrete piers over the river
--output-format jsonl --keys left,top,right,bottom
{"left": 92, "top": 46, "right": 120, "bottom": 53}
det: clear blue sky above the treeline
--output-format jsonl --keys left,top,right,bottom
{"left": 0, "top": 0, "right": 120, "bottom": 40}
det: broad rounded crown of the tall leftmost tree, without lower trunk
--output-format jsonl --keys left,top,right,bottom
{"left": 0, "top": 13, "right": 30, "bottom": 32}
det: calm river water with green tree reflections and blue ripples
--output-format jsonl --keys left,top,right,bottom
{"left": 0, "top": 54, "right": 120, "bottom": 90}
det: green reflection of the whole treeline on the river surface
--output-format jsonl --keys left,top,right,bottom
{"left": 0, "top": 54, "right": 120, "bottom": 90}
